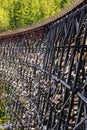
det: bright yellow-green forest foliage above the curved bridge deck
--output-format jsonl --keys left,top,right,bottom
{"left": 0, "top": 0, "right": 72, "bottom": 32}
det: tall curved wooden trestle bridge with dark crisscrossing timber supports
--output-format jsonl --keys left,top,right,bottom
{"left": 0, "top": 0, "right": 87, "bottom": 130}
